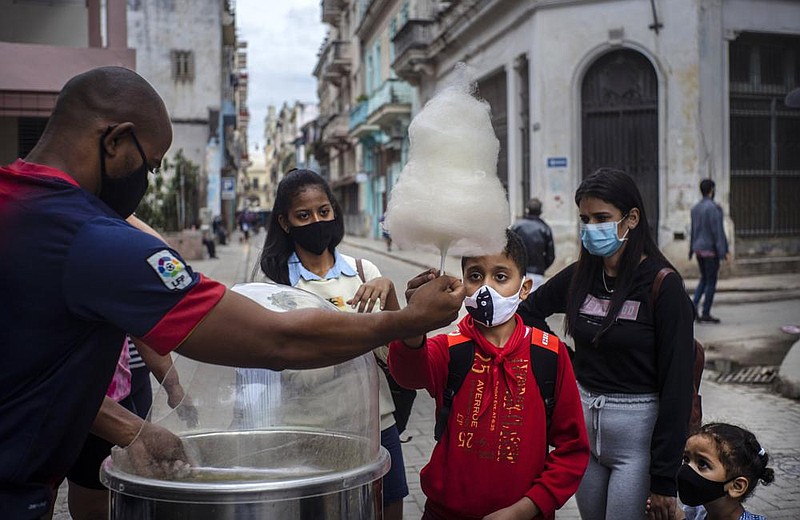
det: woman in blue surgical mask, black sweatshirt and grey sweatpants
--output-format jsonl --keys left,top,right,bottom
{"left": 519, "top": 169, "right": 694, "bottom": 520}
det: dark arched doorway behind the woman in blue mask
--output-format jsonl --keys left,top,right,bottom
{"left": 581, "top": 49, "right": 658, "bottom": 237}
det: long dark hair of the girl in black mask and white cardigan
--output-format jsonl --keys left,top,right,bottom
{"left": 259, "top": 169, "right": 344, "bottom": 285}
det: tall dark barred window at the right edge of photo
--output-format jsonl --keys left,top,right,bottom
{"left": 730, "top": 34, "right": 800, "bottom": 237}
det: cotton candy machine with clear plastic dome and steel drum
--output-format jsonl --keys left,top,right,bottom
{"left": 100, "top": 283, "right": 390, "bottom": 520}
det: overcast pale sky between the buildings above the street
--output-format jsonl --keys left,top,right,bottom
{"left": 236, "top": 0, "right": 325, "bottom": 150}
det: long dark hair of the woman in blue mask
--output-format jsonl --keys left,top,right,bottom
{"left": 565, "top": 168, "right": 675, "bottom": 343}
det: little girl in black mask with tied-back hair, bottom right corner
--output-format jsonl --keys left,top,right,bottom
{"left": 678, "top": 423, "right": 775, "bottom": 520}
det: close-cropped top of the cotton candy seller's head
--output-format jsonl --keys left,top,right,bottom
{"left": 51, "top": 67, "right": 169, "bottom": 140}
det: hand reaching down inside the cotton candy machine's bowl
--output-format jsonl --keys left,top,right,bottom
{"left": 114, "top": 422, "right": 192, "bottom": 480}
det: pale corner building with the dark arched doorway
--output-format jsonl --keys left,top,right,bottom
{"left": 390, "top": 0, "right": 800, "bottom": 271}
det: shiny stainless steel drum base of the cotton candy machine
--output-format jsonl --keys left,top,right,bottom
{"left": 100, "top": 430, "right": 390, "bottom": 520}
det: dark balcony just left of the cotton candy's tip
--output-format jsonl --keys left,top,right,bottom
{"left": 392, "top": 20, "right": 436, "bottom": 85}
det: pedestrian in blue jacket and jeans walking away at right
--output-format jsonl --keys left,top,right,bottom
{"left": 689, "top": 179, "right": 730, "bottom": 323}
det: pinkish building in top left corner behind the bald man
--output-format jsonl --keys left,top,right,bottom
{"left": 0, "top": 0, "right": 136, "bottom": 164}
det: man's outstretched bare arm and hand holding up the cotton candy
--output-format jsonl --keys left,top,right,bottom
{"left": 172, "top": 276, "right": 464, "bottom": 370}
